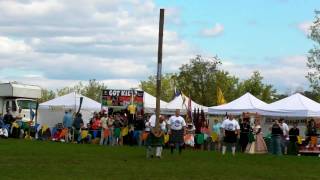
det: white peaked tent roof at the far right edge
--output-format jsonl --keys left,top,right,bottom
{"left": 268, "top": 93, "right": 320, "bottom": 117}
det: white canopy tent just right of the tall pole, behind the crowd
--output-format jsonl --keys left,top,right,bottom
{"left": 165, "top": 94, "right": 208, "bottom": 113}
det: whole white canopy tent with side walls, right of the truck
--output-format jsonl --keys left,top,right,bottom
{"left": 38, "top": 92, "right": 101, "bottom": 127}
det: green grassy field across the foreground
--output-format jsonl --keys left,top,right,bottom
{"left": 0, "top": 139, "right": 320, "bottom": 180}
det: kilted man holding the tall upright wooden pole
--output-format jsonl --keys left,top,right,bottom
{"left": 146, "top": 115, "right": 166, "bottom": 158}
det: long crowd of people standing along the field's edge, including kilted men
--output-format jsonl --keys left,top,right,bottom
{"left": 0, "top": 107, "right": 318, "bottom": 158}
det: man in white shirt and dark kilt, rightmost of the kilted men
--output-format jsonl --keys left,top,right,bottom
{"left": 221, "top": 115, "right": 240, "bottom": 155}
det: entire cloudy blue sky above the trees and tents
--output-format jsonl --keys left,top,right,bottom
{"left": 0, "top": 0, "right": 320, "bottom": 92}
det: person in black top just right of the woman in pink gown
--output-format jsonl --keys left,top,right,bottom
{"left": 270, "top": 120, "right": 283, "bottom": 155}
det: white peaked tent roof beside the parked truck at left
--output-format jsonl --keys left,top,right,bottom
{"left": 39, "top": 92, "right": 101, "bottom": 110}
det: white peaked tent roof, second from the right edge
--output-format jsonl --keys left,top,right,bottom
{"left": 209, "top": 92, "right": 267, "bottom": 114}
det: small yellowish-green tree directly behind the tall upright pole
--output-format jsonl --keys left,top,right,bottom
{"left": 140, "top": 74, "right": 175, "bottom": 102}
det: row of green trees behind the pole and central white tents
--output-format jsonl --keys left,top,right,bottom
{"left": 140, "top": 55, "right": 278, "bottom": 106}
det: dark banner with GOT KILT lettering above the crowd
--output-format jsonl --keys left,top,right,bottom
{"left": 102, "top": 89, "right": 143, "bottom": 109}
